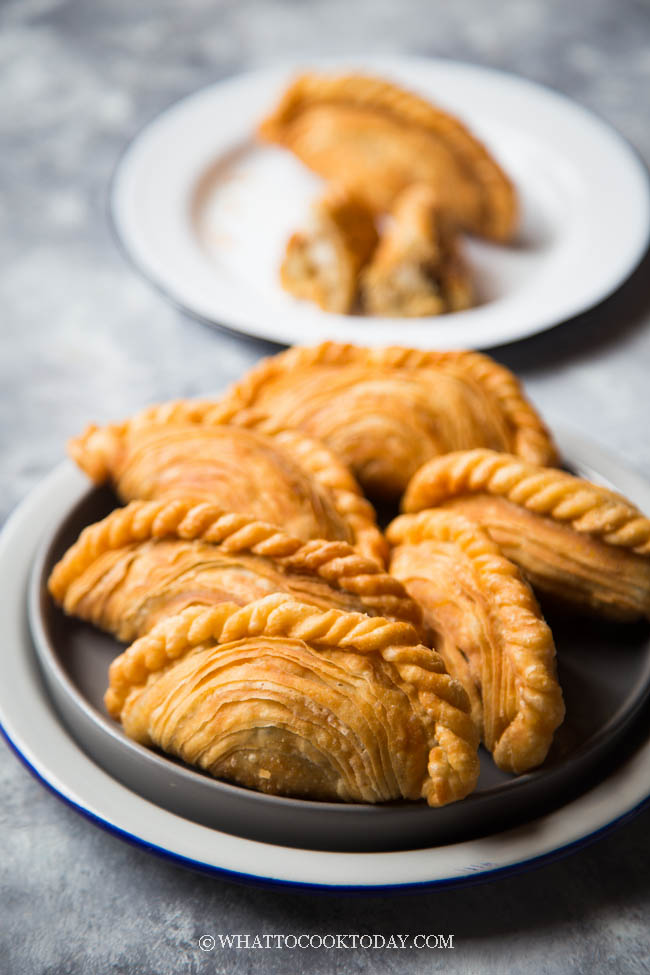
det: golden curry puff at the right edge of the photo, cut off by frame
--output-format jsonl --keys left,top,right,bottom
{"left": 403, "top": 450, "right": 650, "bottom": 620}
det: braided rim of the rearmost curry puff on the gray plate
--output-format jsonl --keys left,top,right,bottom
{"left": 210, "top": 341, "right": 559, "bottom": 464}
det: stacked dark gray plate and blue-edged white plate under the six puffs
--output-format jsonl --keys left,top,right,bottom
{"left": 0, "top": 435, "right": 650, "bottom": 889}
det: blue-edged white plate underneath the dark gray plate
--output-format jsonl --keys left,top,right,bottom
{"left": 0, "top": 436, "right": 650, "bottom": 890}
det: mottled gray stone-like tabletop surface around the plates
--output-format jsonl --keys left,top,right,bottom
{"left": 0, "top": 0, "right": 650, "bottom": 975}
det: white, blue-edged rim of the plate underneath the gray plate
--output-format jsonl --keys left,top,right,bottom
{"left": 0, "top": 434, "right": 650, "bottom": 892}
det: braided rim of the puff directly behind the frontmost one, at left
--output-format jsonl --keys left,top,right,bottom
{"left": 48, "top": 499, "right": 421, "bottom": 624}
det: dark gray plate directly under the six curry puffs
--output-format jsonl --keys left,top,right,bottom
{"left": 29, "top": 437, "right": 650, "bottom": 851}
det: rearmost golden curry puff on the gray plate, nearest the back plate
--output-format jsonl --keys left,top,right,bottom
{"left": 213, "top": 342, "right": 557, "bottom": 498}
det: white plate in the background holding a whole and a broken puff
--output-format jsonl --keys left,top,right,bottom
{"left": 111, "top": 57, "right": 650, "bottom": 348}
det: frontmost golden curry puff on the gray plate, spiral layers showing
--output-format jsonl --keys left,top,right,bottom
{"left": 105, "top": 595, "right": 478, "bottom": 806}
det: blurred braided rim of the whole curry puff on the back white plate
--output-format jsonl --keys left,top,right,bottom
{"left": 258, "top": 72, "right": 518, "bottom": 240}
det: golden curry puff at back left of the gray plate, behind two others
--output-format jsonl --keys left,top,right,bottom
{"left": 69, "top": 408, "right": 385, "bottom": 561}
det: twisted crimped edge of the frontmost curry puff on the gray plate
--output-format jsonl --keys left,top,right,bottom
{"left": 104, "top": 593, "right": 479, "bottom": 806}
